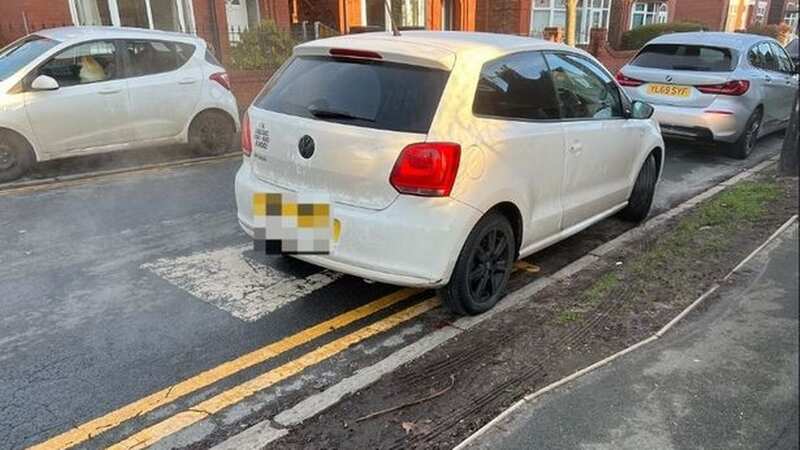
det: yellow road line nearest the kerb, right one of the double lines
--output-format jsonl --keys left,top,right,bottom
{"left": 108, "top": 297, "right": 441, "bottom": 450}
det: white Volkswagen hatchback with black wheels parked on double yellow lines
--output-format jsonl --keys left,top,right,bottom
{"left": 236, "top": 32, "right": 664, "bottom": 314}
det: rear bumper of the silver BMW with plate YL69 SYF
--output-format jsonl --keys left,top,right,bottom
{"left": 653, "top": 104, "right": 752, "bottom": 142}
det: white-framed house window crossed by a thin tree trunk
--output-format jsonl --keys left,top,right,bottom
{"left": 531, "top": 0, "right": 611, "bottom": 44}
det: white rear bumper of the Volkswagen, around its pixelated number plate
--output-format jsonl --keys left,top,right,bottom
{"left": 231, "top": 158, "right": 481, "bottom": 287}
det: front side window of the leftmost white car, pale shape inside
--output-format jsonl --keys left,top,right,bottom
{"left": 39, "top": 41, "right": 118, "bottom": 87}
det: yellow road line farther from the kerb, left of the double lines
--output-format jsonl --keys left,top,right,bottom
{"left": 31, "top": 288, "right": 423, "bottom": 450}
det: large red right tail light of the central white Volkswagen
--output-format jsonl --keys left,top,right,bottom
{"left": 389, "top": 142, "right": 461, "bottom": 197}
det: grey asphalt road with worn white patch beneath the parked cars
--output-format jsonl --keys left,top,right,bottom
{"left": 0, "top": 137, "right": 781, "bottom": 449}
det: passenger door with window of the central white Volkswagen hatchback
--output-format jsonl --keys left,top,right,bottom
{"left": 546, "top": 53, "right": 643, "bottom": 230}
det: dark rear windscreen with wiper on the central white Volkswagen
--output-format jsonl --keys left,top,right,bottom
{"left": 254, "top": 56, "right": 449, "bottom": 133}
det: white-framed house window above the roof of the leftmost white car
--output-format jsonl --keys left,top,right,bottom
{"left": 69, "top": 0, "right": 195, "bottom": 33}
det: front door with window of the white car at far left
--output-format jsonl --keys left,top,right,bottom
{"left": 25, "top": 41, "right": 131, "bottom": 155}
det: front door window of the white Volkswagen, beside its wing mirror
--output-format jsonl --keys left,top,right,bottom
{"left": 546, "top": 53, "right": 623, "bottom": 119}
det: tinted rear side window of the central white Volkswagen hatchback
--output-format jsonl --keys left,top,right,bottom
{"left": 472, "top": 52, "right": 559, "bottom": 120}
